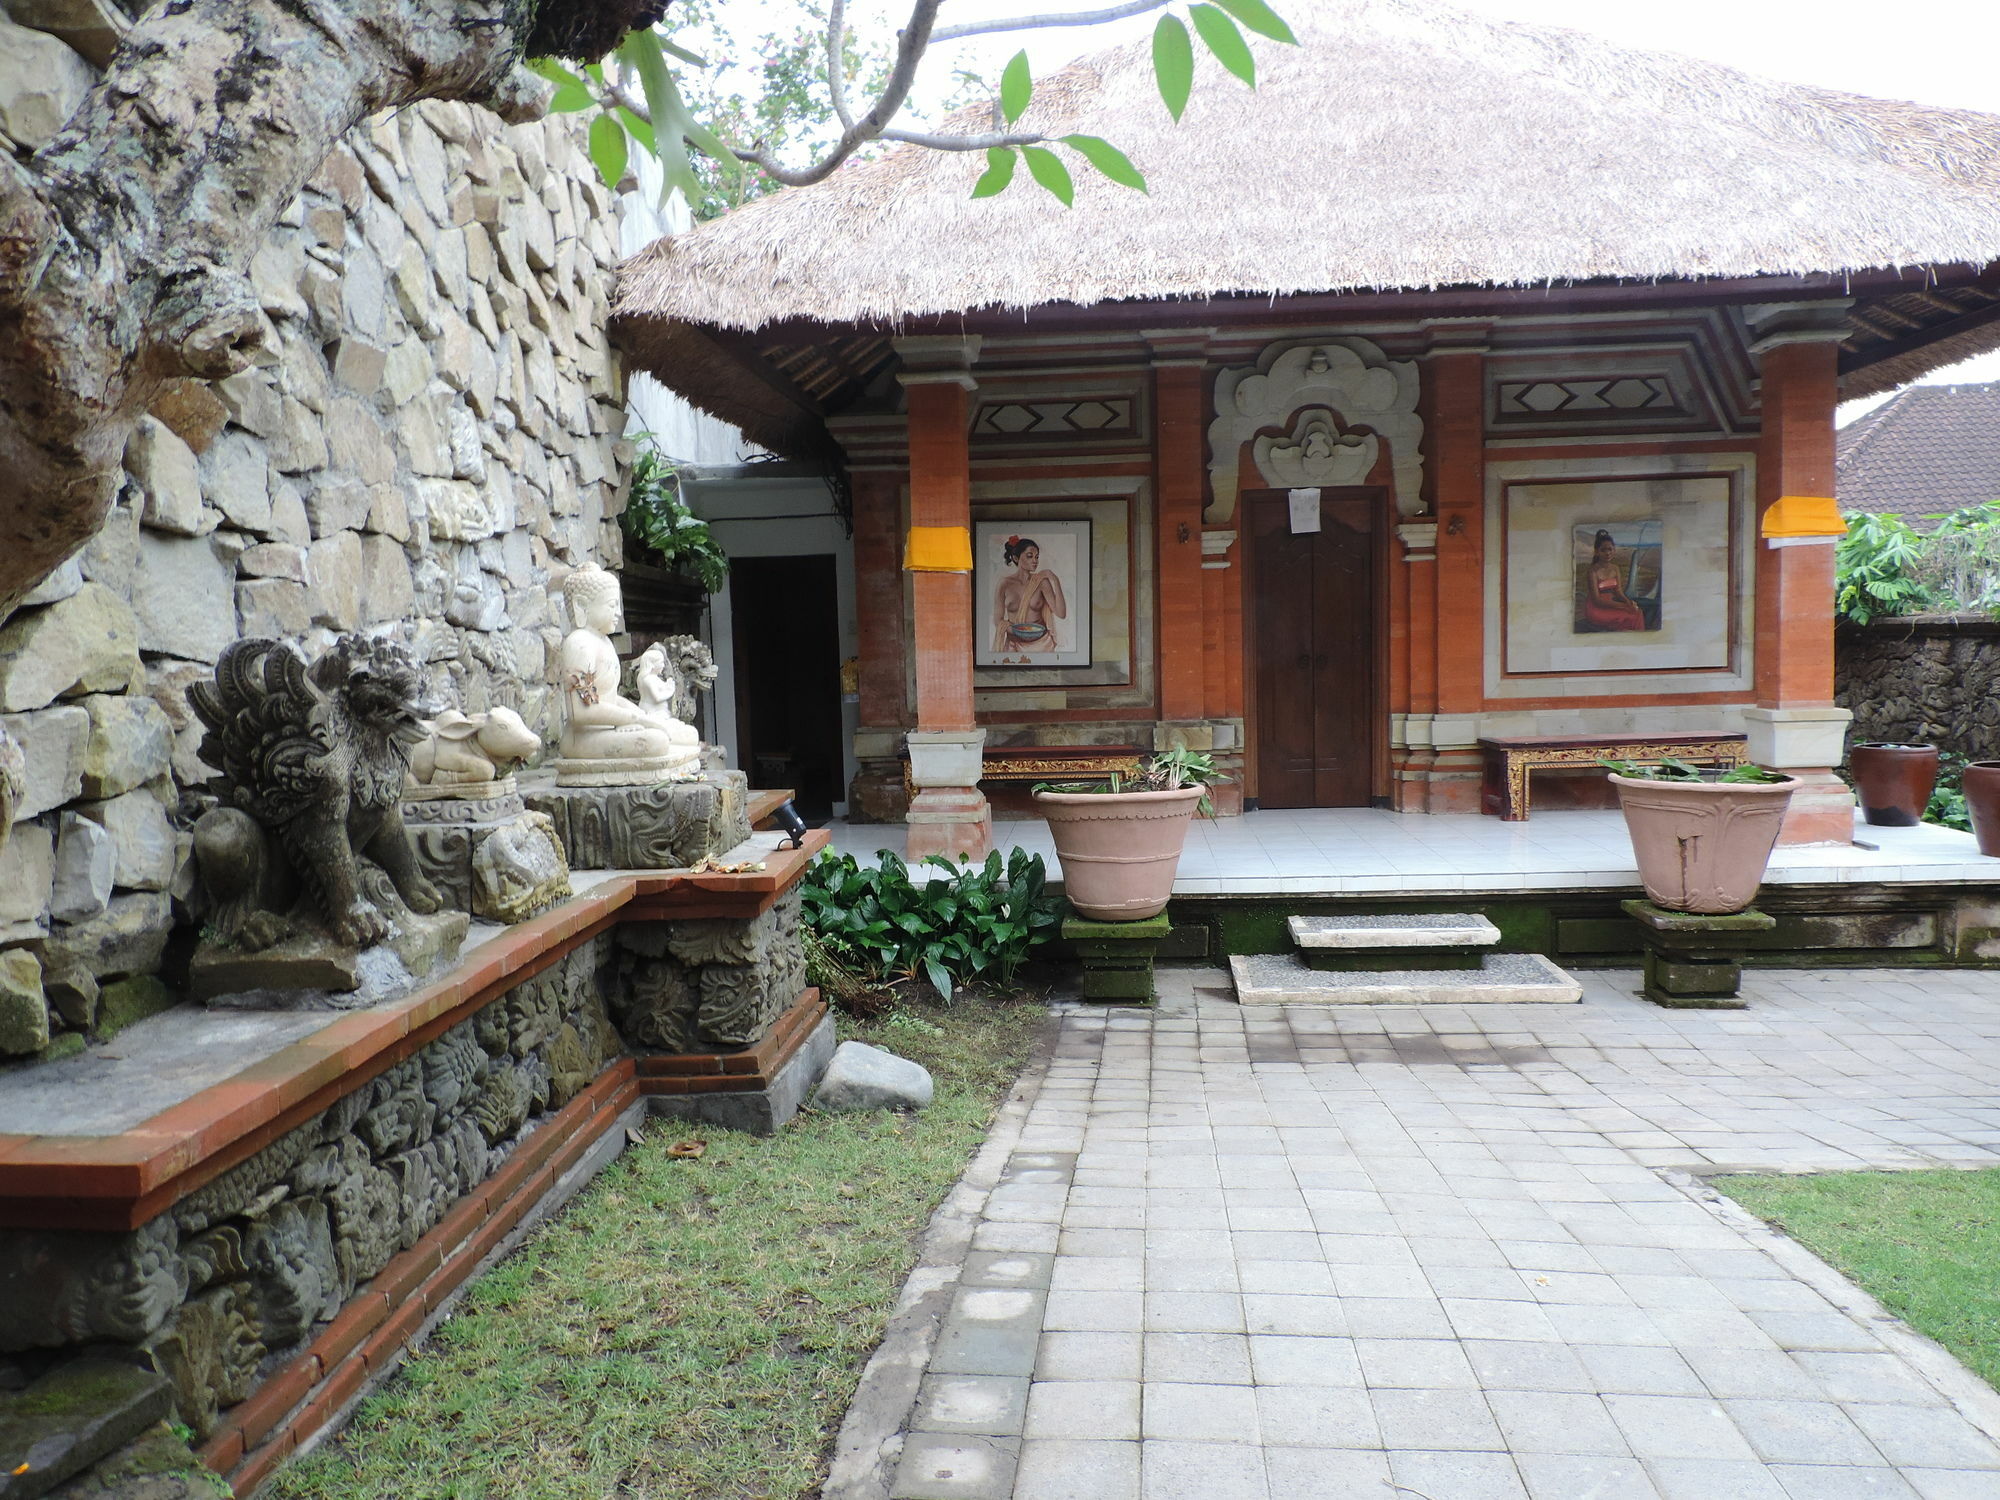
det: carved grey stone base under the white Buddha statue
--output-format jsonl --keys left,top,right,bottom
{"left": 522, "top": 770, "right": 750, "bottom": 870}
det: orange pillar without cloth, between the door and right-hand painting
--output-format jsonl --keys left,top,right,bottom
{"left": 1412, "top": 350, "right": 1486, "bottom": 812}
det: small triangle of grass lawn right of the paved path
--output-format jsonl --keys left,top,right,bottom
{"left": 1714, "top": 1170, "right": 2000, "bottom": 1386}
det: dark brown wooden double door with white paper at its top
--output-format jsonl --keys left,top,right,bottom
{"left": 1244, "top": 488, "right": 1384, "bottom": 808}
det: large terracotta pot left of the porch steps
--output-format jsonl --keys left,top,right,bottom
{"left": 1034, "top": 786, "right": 1202, "bottom": 922}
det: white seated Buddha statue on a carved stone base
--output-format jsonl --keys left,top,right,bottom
{"left": 556, "top": 562, "right": 702, "bottom": 786}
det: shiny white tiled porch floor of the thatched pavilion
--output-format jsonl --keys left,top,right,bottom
{"left": 832, "top": 808, "right": 2000, "bottom": 896}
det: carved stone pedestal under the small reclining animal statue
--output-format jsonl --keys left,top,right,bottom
{"left": 402, "top": 776, "right": 570, "bottom": 922}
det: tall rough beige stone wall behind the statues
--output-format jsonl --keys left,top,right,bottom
{"left": 0, "top": 20, "right": 626, "bottom": 1060}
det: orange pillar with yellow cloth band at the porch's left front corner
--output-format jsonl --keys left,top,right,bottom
{"left": 902, "top": 360, "right": 992, "bottom": 860}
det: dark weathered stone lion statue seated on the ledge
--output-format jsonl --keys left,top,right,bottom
{"left": 188, "top": 634, "right": 464, "bottom": 1012}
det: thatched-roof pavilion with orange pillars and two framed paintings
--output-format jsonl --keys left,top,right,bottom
{"left": 614, "top": 0, "right": 2000, "bottom": 854}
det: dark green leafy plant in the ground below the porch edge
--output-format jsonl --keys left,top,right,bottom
{"left": 800, "top": 850, "right": 1060, "bottom": 1002}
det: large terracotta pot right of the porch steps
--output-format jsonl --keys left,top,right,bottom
{"left": 1610, "top": 774, "right": 1798, "bottom": 916}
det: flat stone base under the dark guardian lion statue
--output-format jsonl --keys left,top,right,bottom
{"left": 188, "top": 912, "right": 472, "bottom": 1010}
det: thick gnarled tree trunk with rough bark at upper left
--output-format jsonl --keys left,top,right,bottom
{"left": 0, "top": 0, "right": 664, "bottom": 620}
